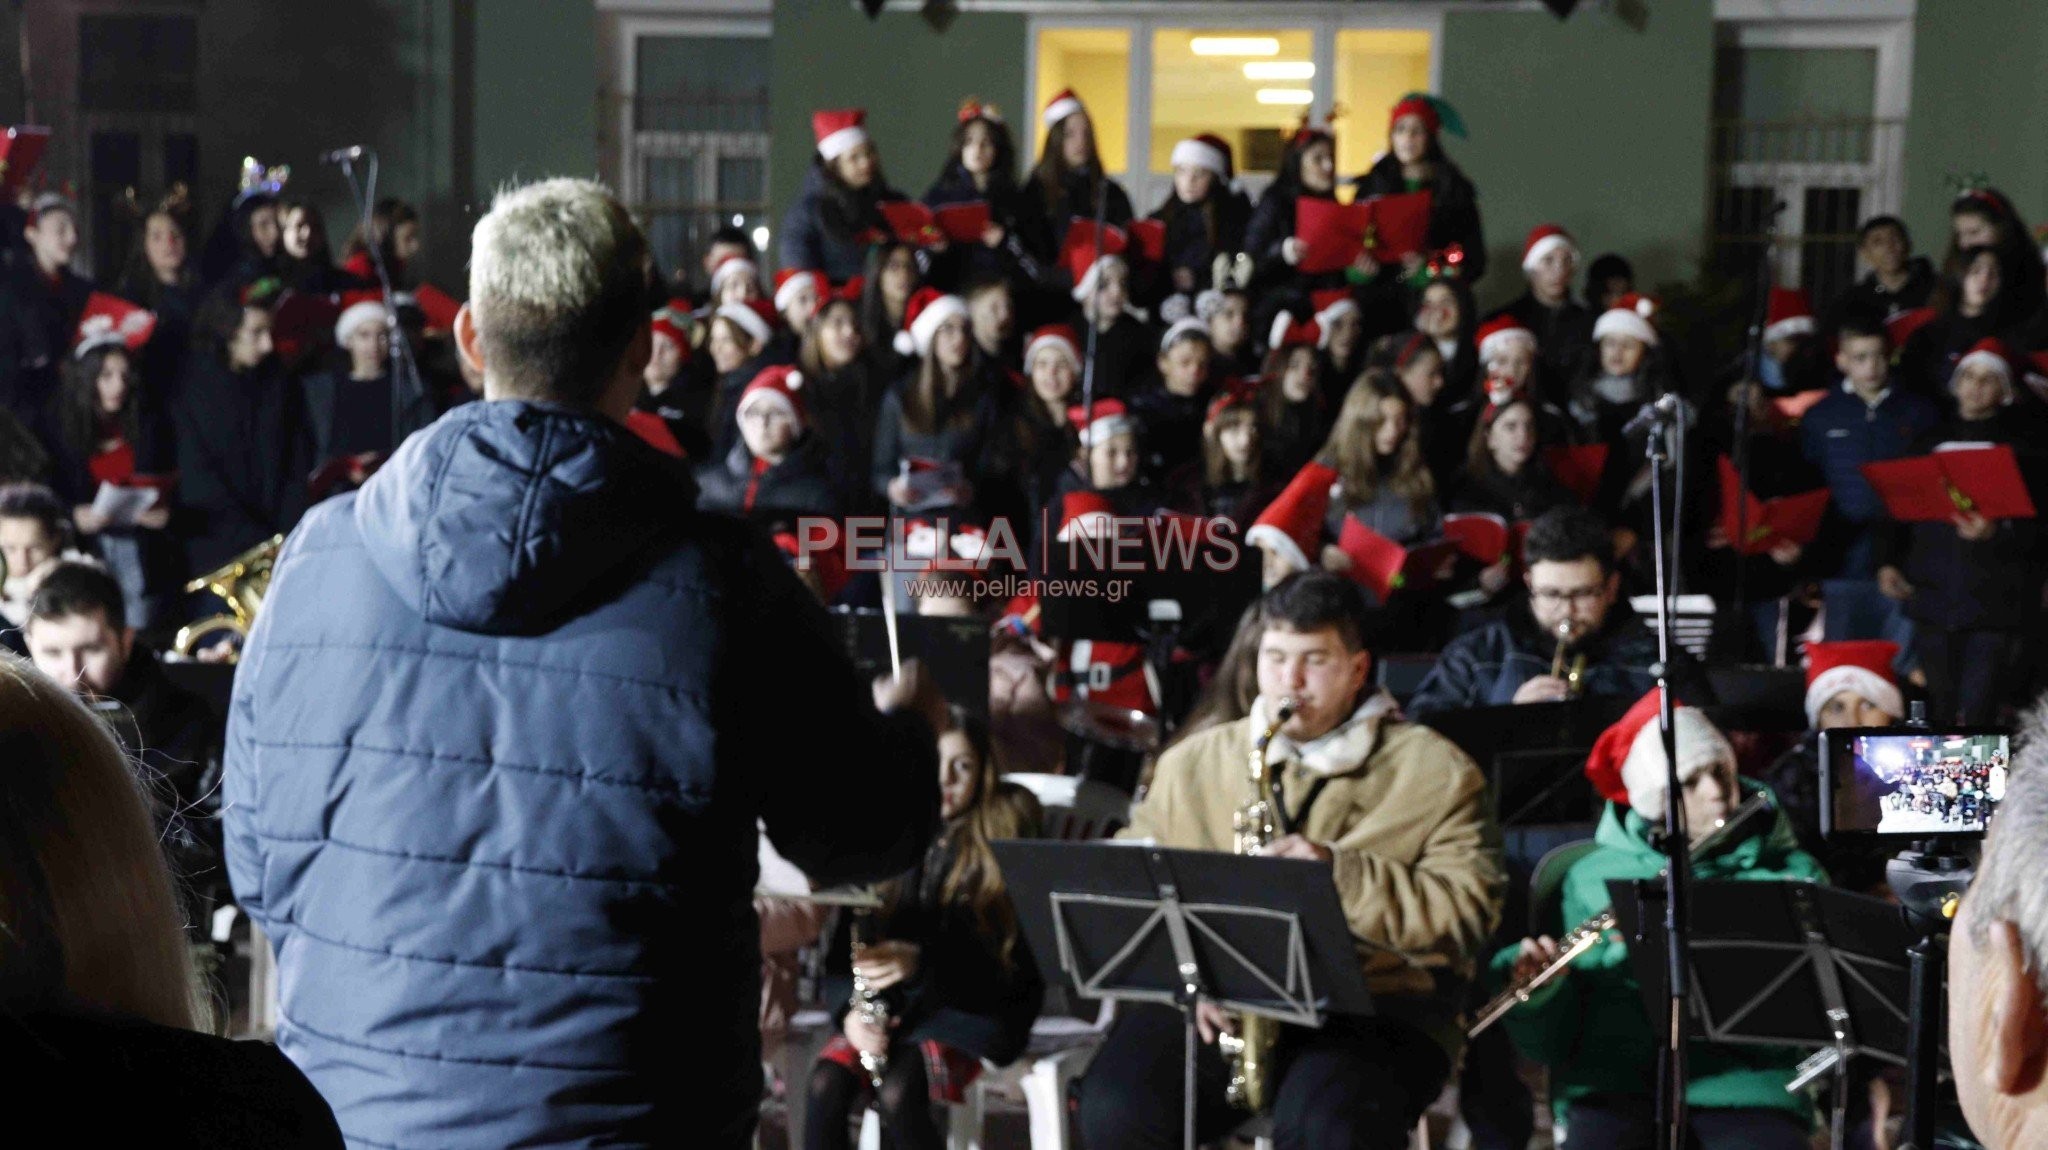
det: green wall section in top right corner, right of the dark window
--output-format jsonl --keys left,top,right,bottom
{"left": 1905, "top": 0, "right": 2048, "bottom": 248}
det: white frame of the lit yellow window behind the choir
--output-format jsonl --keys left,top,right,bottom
{"left": 1019, "top": 0, "right": 1449, "bottom": 213}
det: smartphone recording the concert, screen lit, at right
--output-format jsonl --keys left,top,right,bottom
{"left": 1821, "top": 726, "right": 2011, "bottom": 839}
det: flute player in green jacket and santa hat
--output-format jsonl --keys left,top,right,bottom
{"left": 1489, "top": 692, "right": 1827, "bottom": 1150}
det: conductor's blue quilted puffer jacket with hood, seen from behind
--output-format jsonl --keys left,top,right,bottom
{"left": 223, "top": 401, "right": 938, "bottom": 1148}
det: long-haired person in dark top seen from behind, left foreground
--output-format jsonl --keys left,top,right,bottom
{"left": 0, "top": 653, "right": 342, "bottom": 1148}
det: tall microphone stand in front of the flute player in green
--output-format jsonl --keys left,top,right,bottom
{"left": 1645, "top": 396, "right": 1692, "bottom": 1150}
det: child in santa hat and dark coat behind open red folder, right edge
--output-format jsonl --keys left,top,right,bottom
{"left": 1872, "top": 331, "right": 2048, "bottom": 722}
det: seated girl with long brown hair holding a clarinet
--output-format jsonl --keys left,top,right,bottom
{"left": 805, "top": 706, "right": 1044, "bottom": 1150}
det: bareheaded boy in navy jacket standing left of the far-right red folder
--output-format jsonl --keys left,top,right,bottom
{"left": 1800, "top": 319, "right": 1942, "bottom": 579}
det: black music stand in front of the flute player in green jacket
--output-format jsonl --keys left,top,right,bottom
{"left": 1608, "top": 878, "right": 1913, "bottom": 1148}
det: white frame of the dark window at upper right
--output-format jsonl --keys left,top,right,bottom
{"left": 1714, "top": 0, "right": 1915, "bottom": 282}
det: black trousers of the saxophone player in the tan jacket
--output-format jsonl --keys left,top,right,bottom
{"left": 1081, "top": 1005, "right": 1450, "bottom": 1150}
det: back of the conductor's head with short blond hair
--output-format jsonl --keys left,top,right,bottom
{"left": 469, "top": 178, "right": 649, "bottom": 405}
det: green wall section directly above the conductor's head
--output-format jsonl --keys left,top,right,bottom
{"left": 471, "top": 0, "right": 598, "bottom": 201}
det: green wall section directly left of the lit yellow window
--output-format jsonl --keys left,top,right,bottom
{"left": 768, "top": 0, "right": 1036, "bottom": 257}
